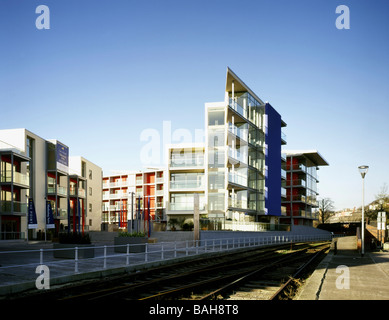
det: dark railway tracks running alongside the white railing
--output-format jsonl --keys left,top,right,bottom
{"left": 9, "top": 242, "right": 329, "bottom": 301}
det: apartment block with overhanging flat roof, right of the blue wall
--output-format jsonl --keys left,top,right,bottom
{"left": 281, "top": 150, "right": 328, "bottom": 226}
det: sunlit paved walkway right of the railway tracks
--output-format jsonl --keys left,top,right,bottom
{"left": 297, "top": 237, "right": 389, "bottom": 300}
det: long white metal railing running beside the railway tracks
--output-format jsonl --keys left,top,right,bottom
{"left": 0, "top": 235, "right": 332, "bottom": 288}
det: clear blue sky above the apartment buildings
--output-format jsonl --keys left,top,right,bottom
{"left": 0, "top": 0, "right": 389, "bottom": 209}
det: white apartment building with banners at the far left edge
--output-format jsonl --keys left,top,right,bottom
{"left": 0, "top": 129, "right": 102, "bottom": 239}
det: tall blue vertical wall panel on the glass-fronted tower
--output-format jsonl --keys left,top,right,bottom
{"left": 265, "top": 103, "right": 281, "bottom": 216}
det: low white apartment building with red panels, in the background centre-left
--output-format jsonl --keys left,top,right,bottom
{"left": 102, "top": 168, "right": 166, "bottom": 231}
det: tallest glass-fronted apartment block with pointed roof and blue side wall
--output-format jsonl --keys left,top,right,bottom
{"left": 167, "top": 68, "right": 286, "bottom": 230}
